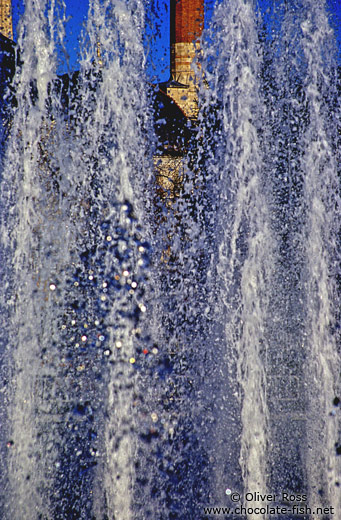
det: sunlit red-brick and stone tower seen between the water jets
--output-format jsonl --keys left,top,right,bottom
{"left": 155, "top": 0, "right": 204, "bottom": 199}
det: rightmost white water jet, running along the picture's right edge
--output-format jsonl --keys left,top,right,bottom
{"left": 301, "top": 1, "right": 341, "bottom": 511}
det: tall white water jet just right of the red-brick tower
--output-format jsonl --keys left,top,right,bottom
{"left": 198, "top": 1, "right": 274, "bottom": 512}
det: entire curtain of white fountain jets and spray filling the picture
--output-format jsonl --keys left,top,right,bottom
{"left": 0, "top": 0, "right": 341, "bottom": 520}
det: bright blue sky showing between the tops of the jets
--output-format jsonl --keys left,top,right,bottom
{"left": 12, "top": 0, "right": 341, "bottom": 81}
